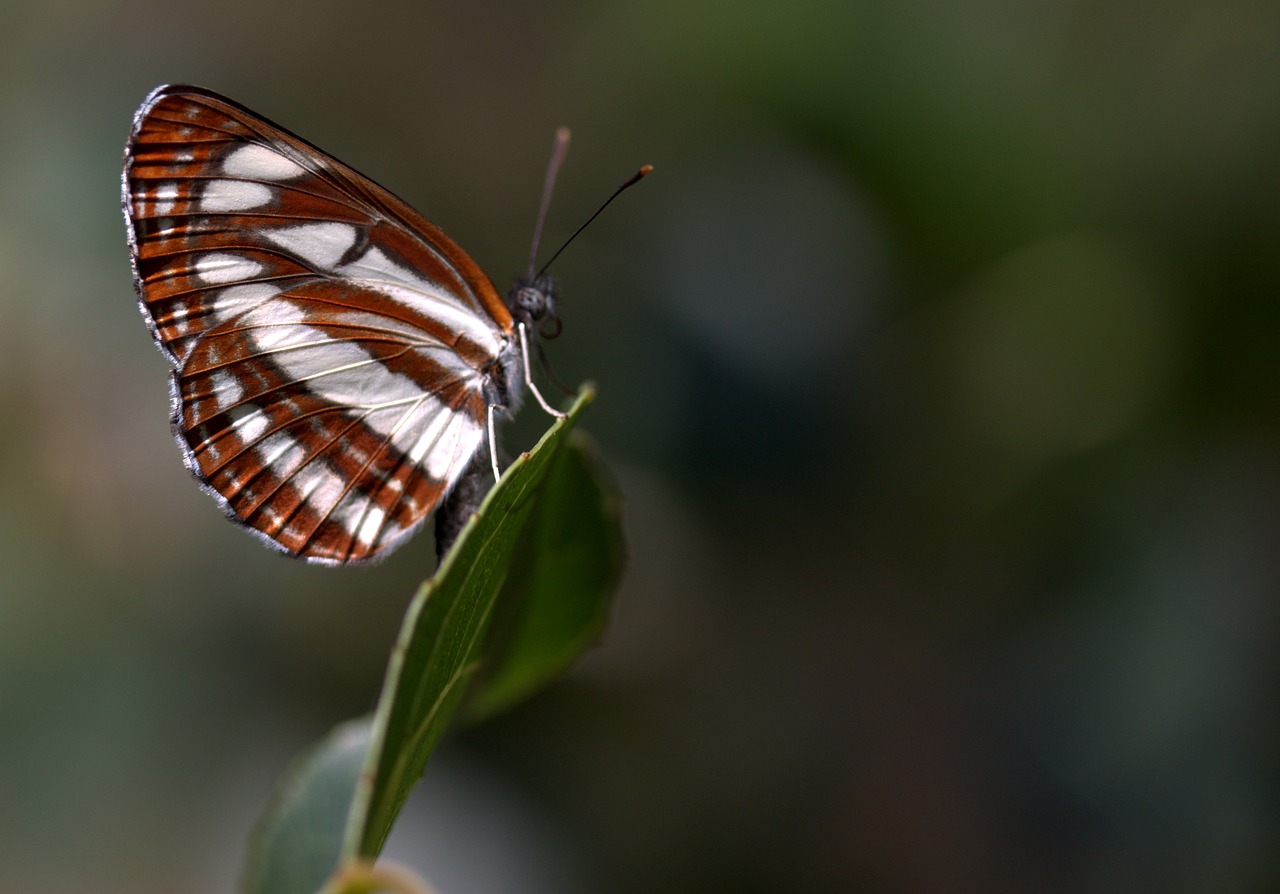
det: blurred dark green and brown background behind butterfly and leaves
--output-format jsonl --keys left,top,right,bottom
{"left": 0, "top": 0, "right": 1280, "bottom": 894}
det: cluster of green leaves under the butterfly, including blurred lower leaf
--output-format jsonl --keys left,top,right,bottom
{"left": 243, "top": 388, "right": 622, "bottom": 894}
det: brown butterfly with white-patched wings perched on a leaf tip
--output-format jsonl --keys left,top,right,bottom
{"left": 122, "top": 86, "right": 648, "bottom": 565}
